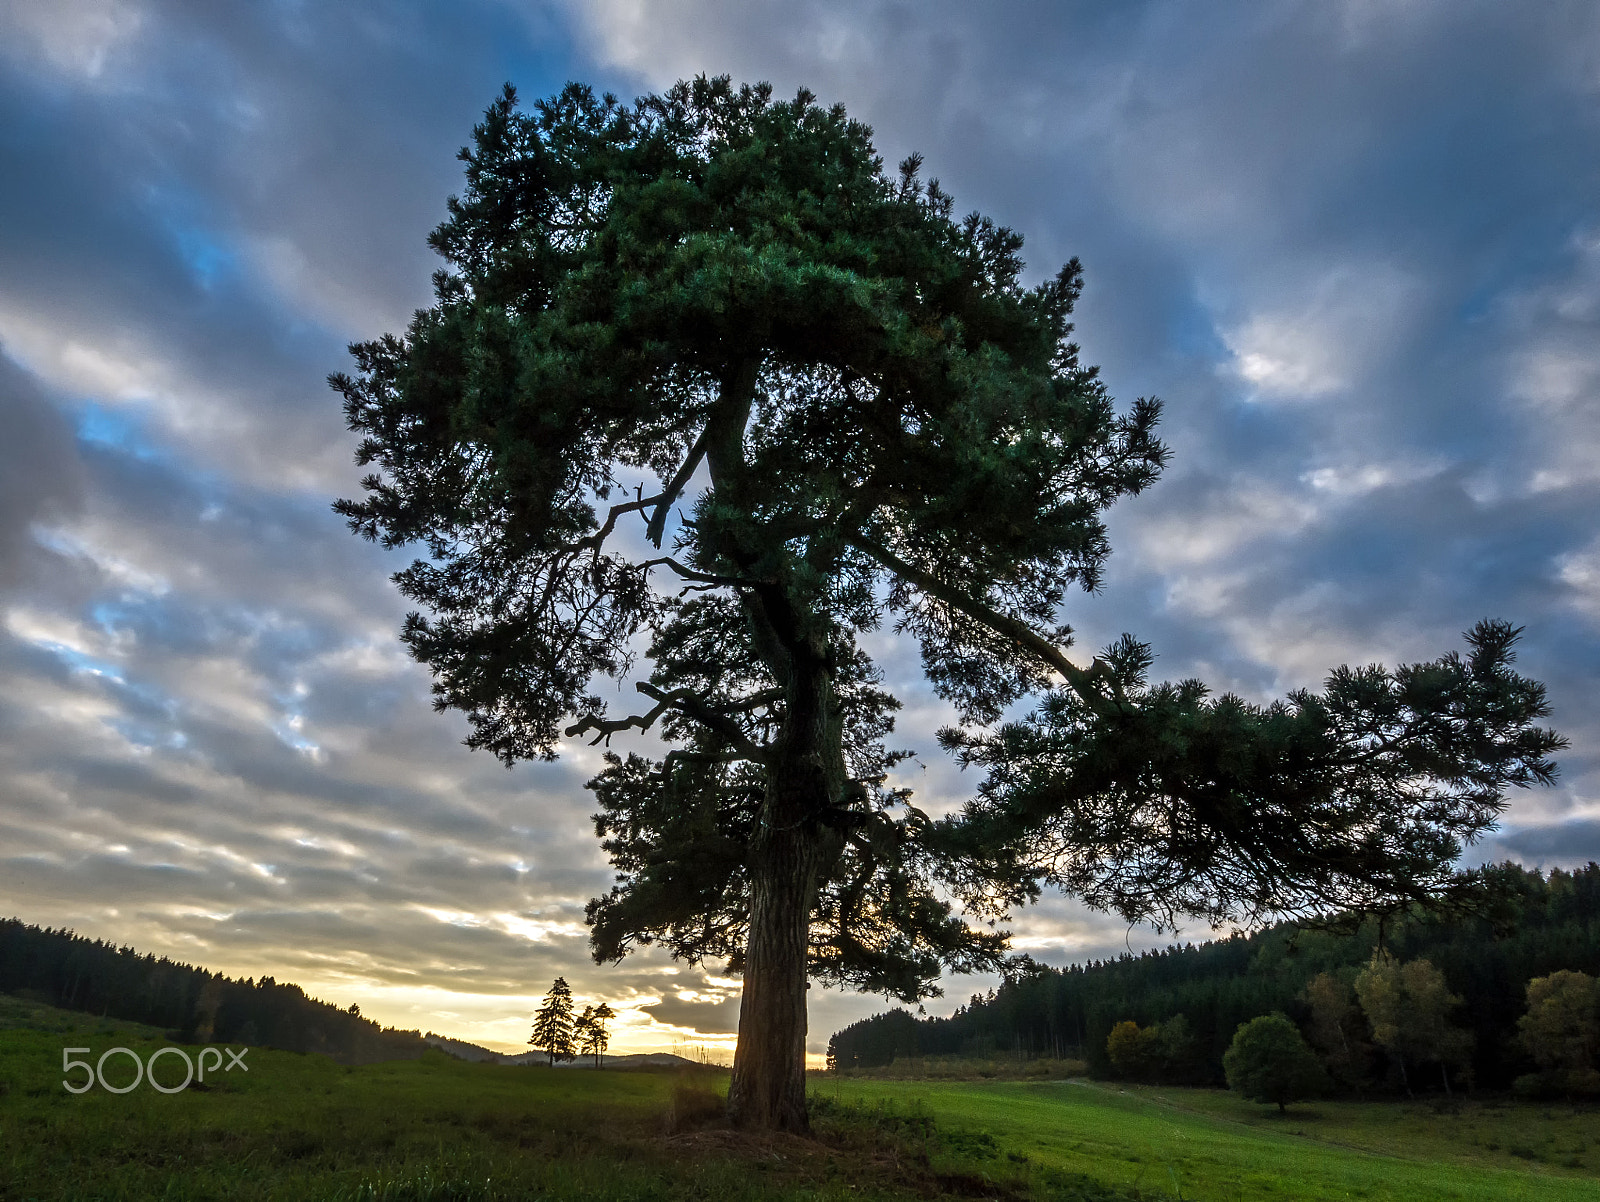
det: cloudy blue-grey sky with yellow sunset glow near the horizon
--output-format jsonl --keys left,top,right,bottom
{"left": 0, "top": 0, "right": 1600, "bottom": 1050}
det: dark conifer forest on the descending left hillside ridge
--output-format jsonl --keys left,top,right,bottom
{"left": 0, "top": 919, "right": 429, "bottom": 1064}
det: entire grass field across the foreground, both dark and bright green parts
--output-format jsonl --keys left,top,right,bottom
{"left": 0, "top": 997, "right": 1600, "bottom": 1202}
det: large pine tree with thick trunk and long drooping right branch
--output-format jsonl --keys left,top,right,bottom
{"left": 333, "top": 78, "right": 1555, "bottom": 1128}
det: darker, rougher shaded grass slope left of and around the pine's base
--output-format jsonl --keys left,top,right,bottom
{"left": 0, "top": 997, "right": 1024, "bottom": 1202}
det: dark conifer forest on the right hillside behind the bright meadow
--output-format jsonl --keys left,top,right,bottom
{"left": 829, "top": 863, "right": 1600, "bottom": 1092}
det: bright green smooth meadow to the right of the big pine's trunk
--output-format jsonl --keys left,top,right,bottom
{"left": 819, "top": 1080, "right": 1600, "bottom": 1202}
